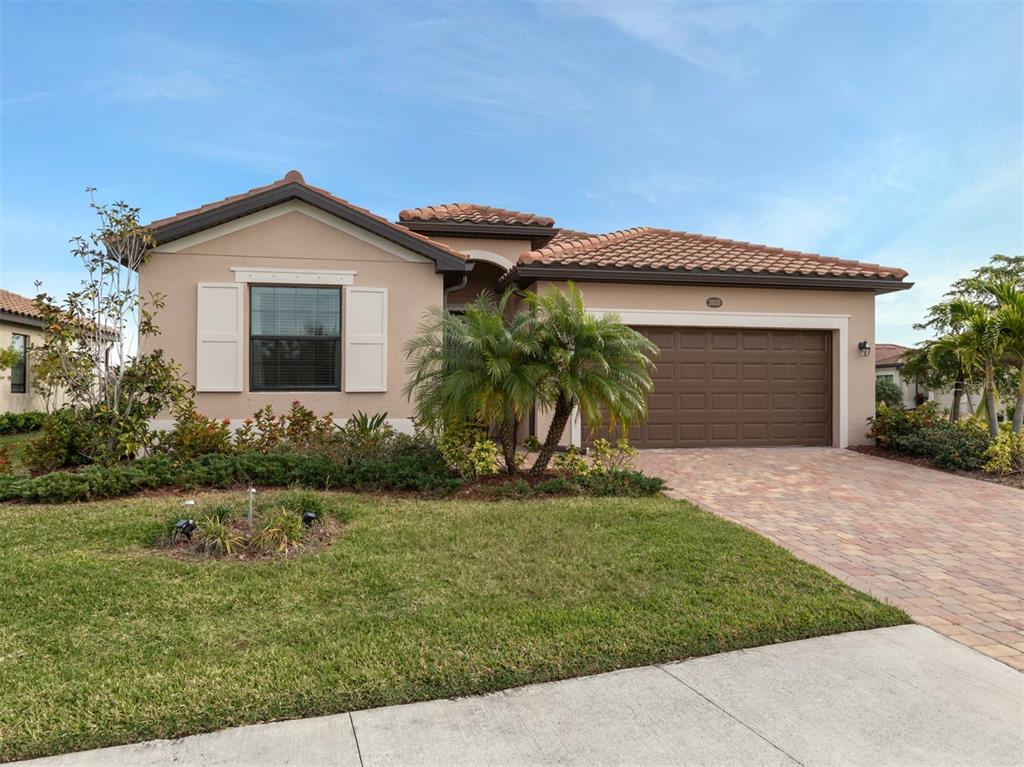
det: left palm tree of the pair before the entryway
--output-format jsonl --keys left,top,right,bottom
{"left": 404, "top": 293, "right": 543, "bottom": 474}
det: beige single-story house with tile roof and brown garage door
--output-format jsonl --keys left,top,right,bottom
{"left": 139, "top": 171, "right": 911, "bottom": 448}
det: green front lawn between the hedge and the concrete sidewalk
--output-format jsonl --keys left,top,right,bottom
{"left": 0, "top": 494, "right": 908, "bottom": 761}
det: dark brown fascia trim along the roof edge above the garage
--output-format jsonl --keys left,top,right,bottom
{"left": 498, "top": 265, "right": 913, "bottom": 293}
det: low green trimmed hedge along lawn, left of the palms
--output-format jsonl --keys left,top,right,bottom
{"left": 0, "top": 453, "right": 462, "bottom": 503}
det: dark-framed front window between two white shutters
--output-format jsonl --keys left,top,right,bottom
{"left": 249, "top": 286, "right": 341, "bottom": 391}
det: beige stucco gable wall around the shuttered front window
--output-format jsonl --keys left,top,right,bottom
{"left": 139, "top": 206, "right": 443, "bottom": 419}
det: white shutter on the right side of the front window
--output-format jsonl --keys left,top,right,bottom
{"left": 344, "top": 287, "right": 387, "bottom": 391}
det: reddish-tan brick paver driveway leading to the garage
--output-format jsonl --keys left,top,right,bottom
{"left": 638, "top": 448, "right": 1024, "bottom": 670}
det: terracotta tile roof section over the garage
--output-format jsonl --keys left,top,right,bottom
{"left": 519, "top": 226, "right": 906, "bottom": 280}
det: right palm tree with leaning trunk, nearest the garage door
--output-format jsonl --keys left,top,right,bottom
{"left": 526, "top": 283, "right": 657, "bottom": 476}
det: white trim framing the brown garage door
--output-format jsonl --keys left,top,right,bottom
{"left": 571, "top": 308, "right": 850, "bottom": 448}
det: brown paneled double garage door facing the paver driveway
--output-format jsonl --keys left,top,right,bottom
{"left": 593, "top": 328, "right": 831, "bottom": 448}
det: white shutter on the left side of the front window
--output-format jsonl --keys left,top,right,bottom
{"left": 196, "top": 283, "right": 245, "bottom": 391}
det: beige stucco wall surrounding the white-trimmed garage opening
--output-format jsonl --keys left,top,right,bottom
{"left": 534, "top": 283, "right": 874, "bottom": 444}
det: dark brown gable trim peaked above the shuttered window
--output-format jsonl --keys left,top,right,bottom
{"left": 154, "top": 182, "right": 468, "bottom": 272}
